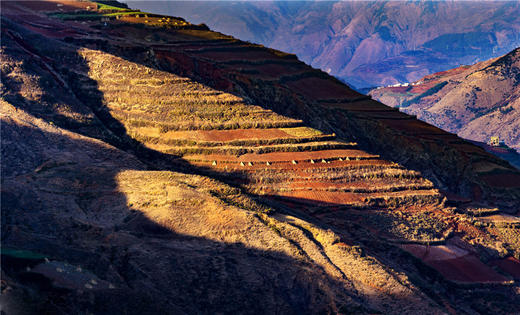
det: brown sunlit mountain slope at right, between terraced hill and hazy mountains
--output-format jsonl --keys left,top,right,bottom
{"left": 370, "top": 48, "right": 520, "bottom": 151}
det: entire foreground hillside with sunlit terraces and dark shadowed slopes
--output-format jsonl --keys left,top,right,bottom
{"left": 0, "top": 0, "right": 520, "bottom": 314}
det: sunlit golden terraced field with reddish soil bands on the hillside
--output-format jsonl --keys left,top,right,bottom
{"left": 81, "top": 49, "right": 443, "bottom": 211}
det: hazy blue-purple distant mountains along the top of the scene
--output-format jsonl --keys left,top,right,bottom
{"left": 126, "top": 1, "right": 520, "bottom": 88}
